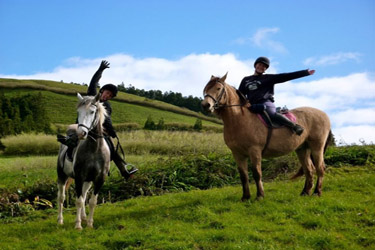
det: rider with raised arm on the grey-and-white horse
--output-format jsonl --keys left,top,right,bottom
{"left": 58, "top": 60, "right": 138, "bottom": 179}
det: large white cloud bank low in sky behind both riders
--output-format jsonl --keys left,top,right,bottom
{"left": 0, "top": 53, "right": 375, "bottom": 144}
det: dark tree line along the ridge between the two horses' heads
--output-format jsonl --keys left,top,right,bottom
{"left": 117, "top": 83, "right": 203, "bottom": 112}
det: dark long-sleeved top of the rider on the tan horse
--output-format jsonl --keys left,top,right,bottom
{"left": 239, "top": 70, "right": 309, "bottom": 104}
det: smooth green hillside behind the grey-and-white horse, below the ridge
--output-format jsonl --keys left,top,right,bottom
{"left": 0, "top": 78, "right": 222, "bottom": 127}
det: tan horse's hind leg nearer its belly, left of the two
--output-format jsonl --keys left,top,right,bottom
{"left": 296, "top": 147, "right": 313, "bottom": 195}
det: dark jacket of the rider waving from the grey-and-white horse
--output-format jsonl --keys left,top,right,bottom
{"left": 87, "top": 69, "right": 117, "bottom": 138}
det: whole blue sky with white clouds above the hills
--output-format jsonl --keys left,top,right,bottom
{"left": 0, "top": 0, "right": 375, "bottom": 145}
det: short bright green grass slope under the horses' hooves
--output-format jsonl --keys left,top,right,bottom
{"left": 0, "top": 167, "right": 375, "bottom": 249}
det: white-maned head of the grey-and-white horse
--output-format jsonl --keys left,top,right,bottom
{"left": 77, "top": 93, "right": 106, "bottom": 139}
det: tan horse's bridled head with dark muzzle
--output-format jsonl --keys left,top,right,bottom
{"left": 201, "top": 73, "right": 228, "bottom": 113}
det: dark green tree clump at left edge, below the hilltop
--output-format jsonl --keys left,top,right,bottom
{"left": 0, "top": 92, "right": 51, "bottom": 137}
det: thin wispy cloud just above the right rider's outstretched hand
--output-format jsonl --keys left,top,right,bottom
{"left": 303, "top": 52, "right": 361, "bottom": 66}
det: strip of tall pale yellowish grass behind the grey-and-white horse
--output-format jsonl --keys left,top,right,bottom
{"left": 1, "top": 130, "right": 230, "bottom": 156}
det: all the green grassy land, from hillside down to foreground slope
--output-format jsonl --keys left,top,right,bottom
{"left": 0, "top": 79, "right": 375, "bottom": 249}
